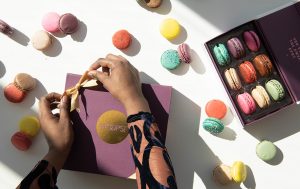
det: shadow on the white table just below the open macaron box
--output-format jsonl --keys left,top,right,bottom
{"left": 244, "top": 105, "right": 300, "bottom": 142}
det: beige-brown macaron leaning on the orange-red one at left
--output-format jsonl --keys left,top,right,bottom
{"left": 14, "top": 73, "right": 36, "bottom": 92}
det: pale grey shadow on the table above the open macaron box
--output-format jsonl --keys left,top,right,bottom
{"left": 179, "top": 0, "right": 294, "bottom": 31}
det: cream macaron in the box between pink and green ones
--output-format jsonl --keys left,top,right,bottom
{"left": 251, "top": 85, "right": 271, "bottom": 108}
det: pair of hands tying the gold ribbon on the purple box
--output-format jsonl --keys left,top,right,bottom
{"left": 39, "top": 54, "right": 150, "bottom": 170}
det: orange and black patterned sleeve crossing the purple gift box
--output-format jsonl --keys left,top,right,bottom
{"left": 127, "top": 112, "right": 177, "bottom": 189}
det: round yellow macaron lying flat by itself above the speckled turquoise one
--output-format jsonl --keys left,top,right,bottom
{"left": 160, "top": 18, "right": 181, "bottom": 40}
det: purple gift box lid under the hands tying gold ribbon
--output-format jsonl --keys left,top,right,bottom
{"left": 64, "top": 74, "right": 172, "bottom": 178}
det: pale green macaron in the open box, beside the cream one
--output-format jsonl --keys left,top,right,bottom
{"left": 266, "top": 79, "right": 285, "bottom": 101}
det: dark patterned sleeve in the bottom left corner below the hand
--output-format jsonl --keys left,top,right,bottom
{"left": 17, "top": 160, "right": 57, "bottom": 189}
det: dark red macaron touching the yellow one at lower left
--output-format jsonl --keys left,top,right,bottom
{"left": 11, "top": 132, "right": 32, "bottom": 151}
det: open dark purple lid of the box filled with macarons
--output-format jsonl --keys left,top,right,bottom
{"left": 256, "top": 2, "right": 300, "bottom": 102}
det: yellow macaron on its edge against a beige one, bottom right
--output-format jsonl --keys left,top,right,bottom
{"left": 231, "top": 161, "right": 247, "bottom": 183}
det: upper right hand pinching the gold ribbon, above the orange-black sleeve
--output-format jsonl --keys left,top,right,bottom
{"left": 88, "top": 54, "right": 150, "bottom": 115}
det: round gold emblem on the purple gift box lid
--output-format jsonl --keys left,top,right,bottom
{"left": 96, "top": 110, "right": 128, "bottom": 144}
